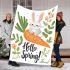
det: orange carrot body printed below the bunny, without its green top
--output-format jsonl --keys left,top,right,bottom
{"left": 24, "top": 30, "right": 50, "bottom": 48}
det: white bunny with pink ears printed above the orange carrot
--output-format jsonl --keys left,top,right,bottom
{"left": 29, "top": 12, "right": 44, "bottom": 35}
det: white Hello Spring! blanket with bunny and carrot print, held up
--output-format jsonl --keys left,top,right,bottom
{"left": 9, "top": 5, "right": 57, "bottom": 65}
